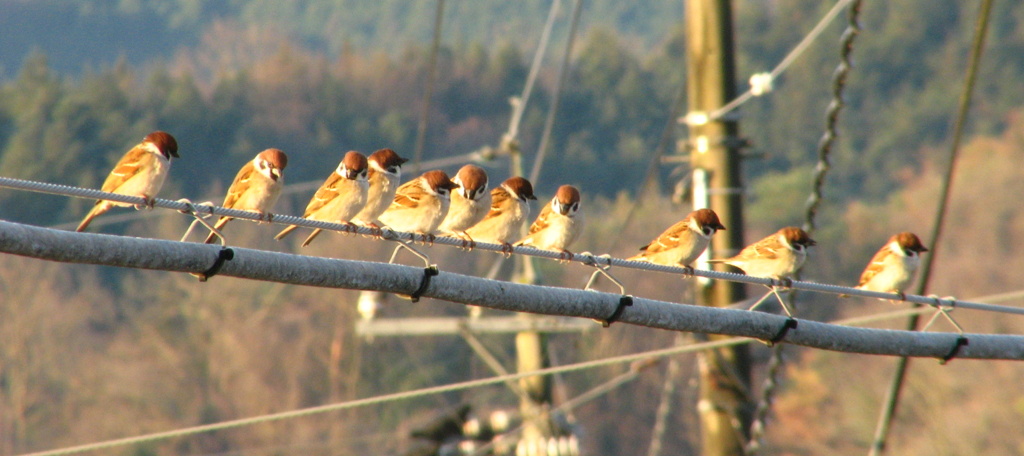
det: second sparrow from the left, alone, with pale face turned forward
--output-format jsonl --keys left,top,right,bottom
{"left": 206, "top": 149, "right": 288, "bottom": 244}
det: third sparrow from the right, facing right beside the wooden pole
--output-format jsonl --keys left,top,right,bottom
{"left": 627, "top": 209, "right": 725, "bottom": 266}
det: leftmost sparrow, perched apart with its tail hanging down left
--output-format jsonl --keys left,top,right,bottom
{"left": 76, "top": 131, "right": 180, "bottom": 232}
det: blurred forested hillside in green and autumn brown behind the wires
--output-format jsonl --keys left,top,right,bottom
{"left": 0, "top": 0, "right": 1024, "bottom": 456}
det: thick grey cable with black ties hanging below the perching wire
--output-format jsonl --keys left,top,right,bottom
{"left": 8, "top": 221, "right": 1024, "bottom": 360}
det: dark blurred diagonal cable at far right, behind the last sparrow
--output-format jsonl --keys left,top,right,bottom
{"left": 867, "top": 0, "right": 992, "bottom": 456}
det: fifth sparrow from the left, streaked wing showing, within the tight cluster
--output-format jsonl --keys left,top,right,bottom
{"left": 380, "top": 169, "right": 459, "bottom": 239}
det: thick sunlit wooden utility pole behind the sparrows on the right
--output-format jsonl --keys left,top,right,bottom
{"left": 685, "top": 0, "right": 754, "bottom": 456}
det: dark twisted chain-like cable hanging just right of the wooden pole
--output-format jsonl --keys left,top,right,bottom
{"left": 746, "top": 0, "right": 861, "bottom": 450}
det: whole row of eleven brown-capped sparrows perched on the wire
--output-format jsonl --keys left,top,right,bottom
{"left": 78, "top": 131, "right": 928, "bottom": 305}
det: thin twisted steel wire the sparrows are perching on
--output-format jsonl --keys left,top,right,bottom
{"left": 0, "top": 177, "right": 1024, "bottom": 315}
